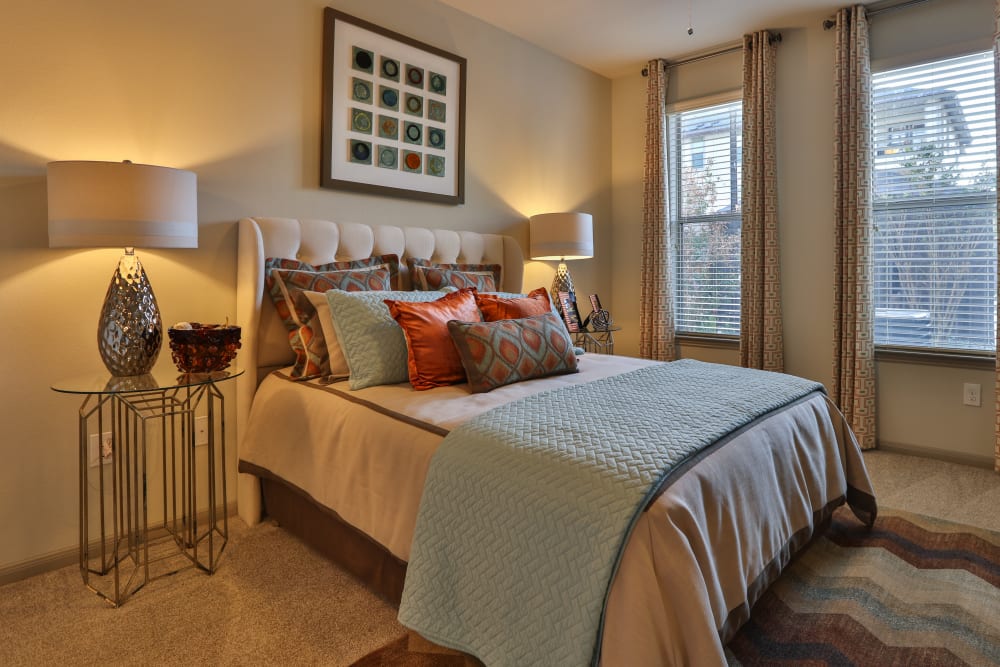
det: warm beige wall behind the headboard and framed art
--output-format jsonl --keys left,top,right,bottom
{"left": 0, "top": 0, "right": 611, "bottom": 574}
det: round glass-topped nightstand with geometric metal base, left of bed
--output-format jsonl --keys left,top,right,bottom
{"left": 52, "top": 370, "right": 242, "bottom": 607}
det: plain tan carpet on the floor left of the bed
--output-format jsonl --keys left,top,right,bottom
{"left": 0, "top": 519, "right": 404, "bottom": 667}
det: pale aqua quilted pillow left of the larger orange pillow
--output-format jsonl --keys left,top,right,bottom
{"left": 326, "top": 290, "right": 454, "bottom": 389}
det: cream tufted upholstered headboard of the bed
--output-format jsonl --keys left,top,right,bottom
{"left": 236, "top": 218, "right": 524, "bottom": 524}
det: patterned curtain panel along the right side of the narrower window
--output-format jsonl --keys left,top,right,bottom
{"left": 740, "top": 30, "right": 785, "bottom": 373}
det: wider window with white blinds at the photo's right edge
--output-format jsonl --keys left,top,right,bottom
{"left": 872, "top": 52, "right": 997, "bottom": 352}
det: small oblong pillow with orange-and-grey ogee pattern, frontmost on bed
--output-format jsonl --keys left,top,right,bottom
{"left": 448, "top": 312, "right": 579, "bottom": 393}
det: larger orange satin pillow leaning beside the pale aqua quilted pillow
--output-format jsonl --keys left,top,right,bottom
{"left": 385, "top": 287, "right": 483, "bottom": 390}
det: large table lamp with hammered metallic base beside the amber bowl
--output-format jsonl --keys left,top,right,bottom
{"left": 47, "top": 160, "right": 198, "bottom": 376}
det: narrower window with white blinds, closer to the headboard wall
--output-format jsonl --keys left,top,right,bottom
{"left": 668, "top": 100, "right": 743, "bottom": 336}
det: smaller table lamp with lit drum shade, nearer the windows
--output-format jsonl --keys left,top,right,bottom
{"left": 528, "top": 213, "right": 594, "bottom": 312}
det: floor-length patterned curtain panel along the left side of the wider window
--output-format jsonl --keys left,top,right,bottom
{"left": 833, "top": 5, "right": 876, "bottom": 449}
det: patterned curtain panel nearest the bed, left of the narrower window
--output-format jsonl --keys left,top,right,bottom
{"left": 639, "top": 60, "right": 675, "bottom": 361}
